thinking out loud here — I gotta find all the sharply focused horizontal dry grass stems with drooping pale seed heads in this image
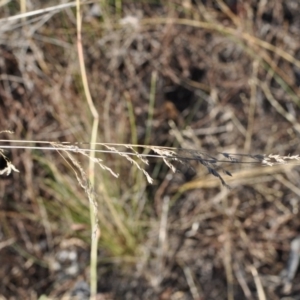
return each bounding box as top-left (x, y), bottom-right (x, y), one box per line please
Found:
top-left (0, 140), bottom-right (300, 188)
